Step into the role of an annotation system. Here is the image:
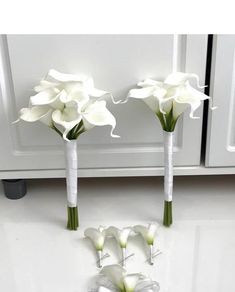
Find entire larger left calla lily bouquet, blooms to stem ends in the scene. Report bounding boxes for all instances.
[17,69,119,230]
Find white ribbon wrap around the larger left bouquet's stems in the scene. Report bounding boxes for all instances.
[65,140,77,207]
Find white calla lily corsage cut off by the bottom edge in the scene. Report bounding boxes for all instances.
[98,265,159,292]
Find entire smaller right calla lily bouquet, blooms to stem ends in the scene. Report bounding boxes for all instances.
[128,72,212,226]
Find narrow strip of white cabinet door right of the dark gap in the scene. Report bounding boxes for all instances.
[206,35,235,167]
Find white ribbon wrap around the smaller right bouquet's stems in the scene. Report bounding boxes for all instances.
[163,131,174,202]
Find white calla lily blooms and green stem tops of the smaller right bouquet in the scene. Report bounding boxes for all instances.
[128,72,210,132]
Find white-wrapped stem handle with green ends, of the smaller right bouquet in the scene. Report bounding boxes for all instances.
[163,131,173,227]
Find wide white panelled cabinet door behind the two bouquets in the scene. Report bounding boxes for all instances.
[0,35,207,176]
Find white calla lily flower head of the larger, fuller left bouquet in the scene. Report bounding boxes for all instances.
[18,69,119,140]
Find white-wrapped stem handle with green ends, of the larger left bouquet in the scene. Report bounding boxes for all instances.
[65,140,79,230]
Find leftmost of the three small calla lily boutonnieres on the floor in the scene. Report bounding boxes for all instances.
[84,226,105,268]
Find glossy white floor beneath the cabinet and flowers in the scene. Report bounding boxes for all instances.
[0,176,235,292]
